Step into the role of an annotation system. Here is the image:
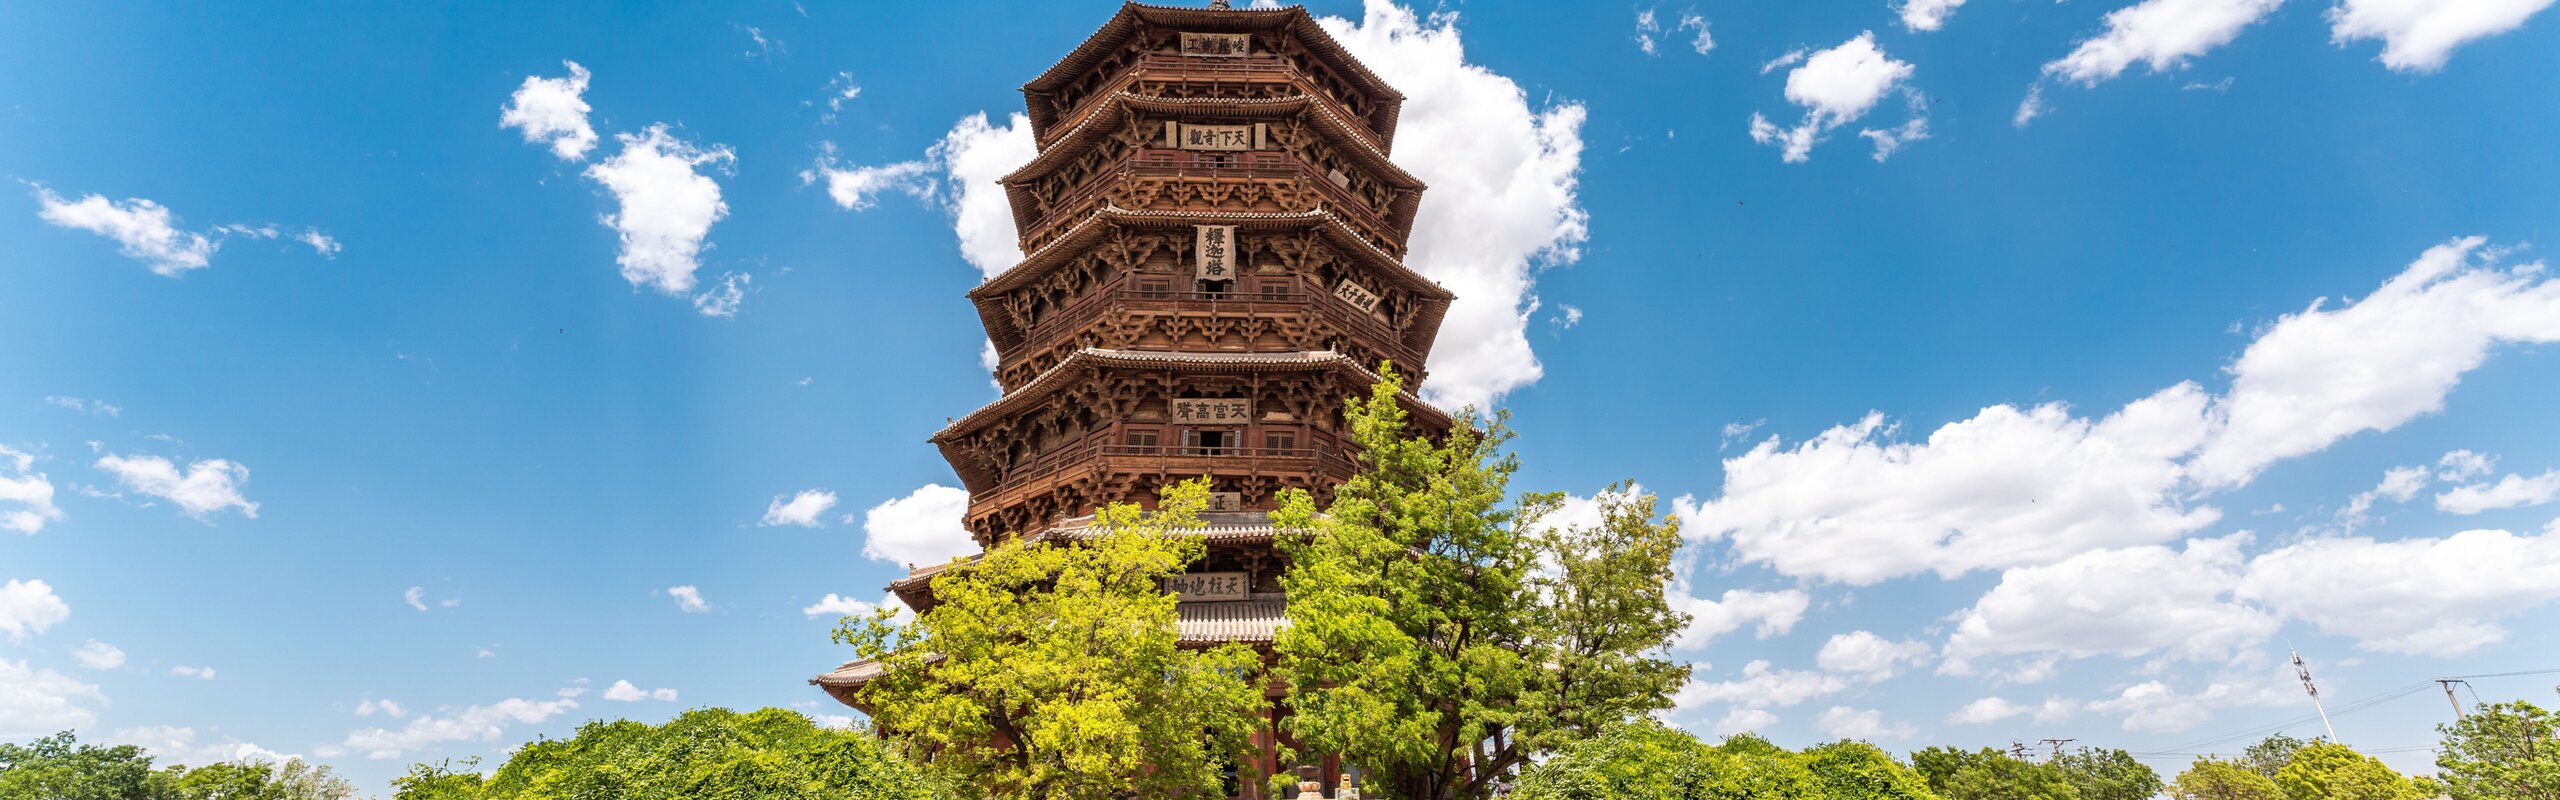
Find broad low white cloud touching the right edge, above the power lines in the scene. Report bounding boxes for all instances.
[2237,531,2560,654]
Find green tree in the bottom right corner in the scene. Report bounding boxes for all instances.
[2435,700,2560,800]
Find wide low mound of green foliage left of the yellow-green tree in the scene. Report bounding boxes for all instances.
[392,708,950,800]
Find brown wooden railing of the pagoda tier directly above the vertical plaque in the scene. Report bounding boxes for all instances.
[1021,149,1403,254]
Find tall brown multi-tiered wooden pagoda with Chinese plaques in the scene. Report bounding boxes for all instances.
[812,3,1452,797]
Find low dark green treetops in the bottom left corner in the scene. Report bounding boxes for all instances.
[0,731,356,800]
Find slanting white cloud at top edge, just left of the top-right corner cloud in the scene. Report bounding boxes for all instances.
[2045,0,2284,87]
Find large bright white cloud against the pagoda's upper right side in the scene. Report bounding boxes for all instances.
[1321,0,1590,405]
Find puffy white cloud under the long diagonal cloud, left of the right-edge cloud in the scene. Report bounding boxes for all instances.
[1946,533,2278,674]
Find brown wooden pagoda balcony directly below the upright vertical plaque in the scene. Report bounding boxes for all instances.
[996,274,1423,376]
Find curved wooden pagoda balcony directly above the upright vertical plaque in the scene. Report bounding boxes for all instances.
[1021,149,1413,259]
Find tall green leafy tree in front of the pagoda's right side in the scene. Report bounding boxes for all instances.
[1272,372,1687,800]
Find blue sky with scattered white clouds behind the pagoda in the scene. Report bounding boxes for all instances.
[0,0,2560,787]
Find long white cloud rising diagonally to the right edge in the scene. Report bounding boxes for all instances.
[1674,238,2560,585]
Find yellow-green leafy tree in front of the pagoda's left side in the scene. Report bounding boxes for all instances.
[837,479,1270,800]
